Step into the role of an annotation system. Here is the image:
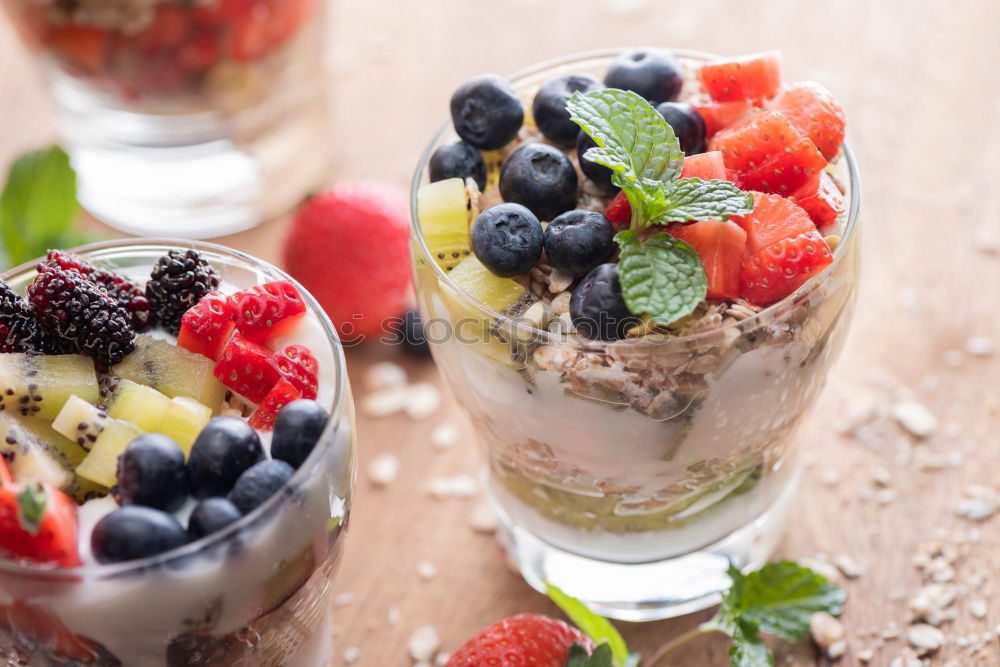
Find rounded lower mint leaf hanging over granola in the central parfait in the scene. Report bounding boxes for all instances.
[615,230,708,325]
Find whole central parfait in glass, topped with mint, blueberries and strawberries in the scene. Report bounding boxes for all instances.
[412,49,858,620]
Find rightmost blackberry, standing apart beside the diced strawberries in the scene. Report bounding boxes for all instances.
[146,250,219,336]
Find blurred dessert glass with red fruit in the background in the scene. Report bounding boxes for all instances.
[0,0,329,238]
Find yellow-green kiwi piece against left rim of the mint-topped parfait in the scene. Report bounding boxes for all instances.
[417,178,478,271]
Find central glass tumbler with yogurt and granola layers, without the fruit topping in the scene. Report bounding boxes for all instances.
[411,50,859,621]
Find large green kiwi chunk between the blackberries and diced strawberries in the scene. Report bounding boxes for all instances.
[111,336,226,414]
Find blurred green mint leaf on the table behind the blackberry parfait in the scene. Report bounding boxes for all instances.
[0,146,78,272]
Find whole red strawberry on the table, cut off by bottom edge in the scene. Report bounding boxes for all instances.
[446,614,594,667]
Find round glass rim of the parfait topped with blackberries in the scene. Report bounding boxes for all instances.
[0,237,349,581]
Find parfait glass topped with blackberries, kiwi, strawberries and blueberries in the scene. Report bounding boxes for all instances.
[0,241,354,666]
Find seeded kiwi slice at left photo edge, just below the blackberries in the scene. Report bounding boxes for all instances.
[0,353,98,419]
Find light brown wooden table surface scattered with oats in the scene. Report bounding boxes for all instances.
[0,0,1000,666]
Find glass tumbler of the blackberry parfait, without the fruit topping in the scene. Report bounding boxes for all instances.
[0,240,355,667]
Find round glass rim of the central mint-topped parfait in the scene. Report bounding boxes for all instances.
[410,47,861,349]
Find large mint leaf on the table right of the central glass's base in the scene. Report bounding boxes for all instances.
[720,561,847,642]
